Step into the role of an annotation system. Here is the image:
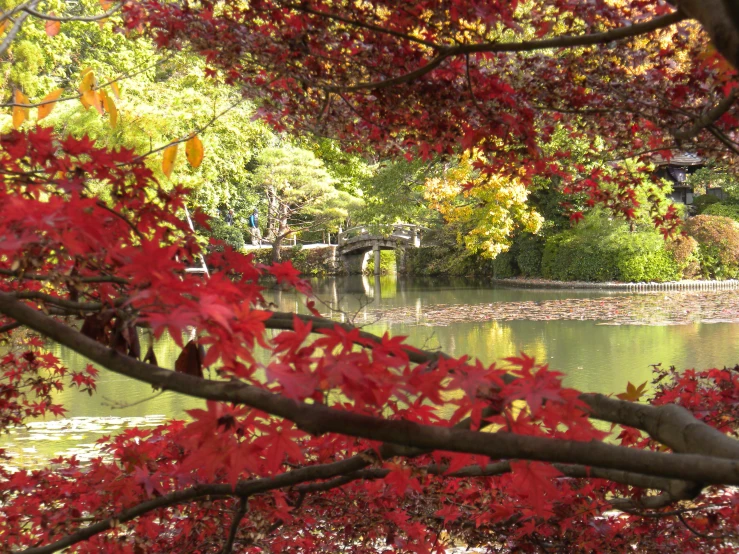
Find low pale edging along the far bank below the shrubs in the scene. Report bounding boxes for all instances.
[490,277,739,292]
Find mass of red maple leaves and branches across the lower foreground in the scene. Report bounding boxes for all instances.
[0,129,739,553]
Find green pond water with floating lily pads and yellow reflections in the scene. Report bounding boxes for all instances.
[0,276,739,467]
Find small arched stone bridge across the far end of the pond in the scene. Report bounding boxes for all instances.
[337,223,423,275]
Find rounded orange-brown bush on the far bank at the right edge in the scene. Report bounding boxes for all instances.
[684,215,739,279]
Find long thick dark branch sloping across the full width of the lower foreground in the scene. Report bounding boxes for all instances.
[0,293,739,485]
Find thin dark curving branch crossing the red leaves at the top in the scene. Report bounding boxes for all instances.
[322,11,687,93]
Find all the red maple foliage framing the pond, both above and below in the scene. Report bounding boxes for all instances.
[0,0,739,554]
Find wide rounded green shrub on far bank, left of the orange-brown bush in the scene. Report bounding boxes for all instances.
[542,213,680,282]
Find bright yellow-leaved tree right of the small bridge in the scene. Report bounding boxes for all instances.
[424,150,544,258]
